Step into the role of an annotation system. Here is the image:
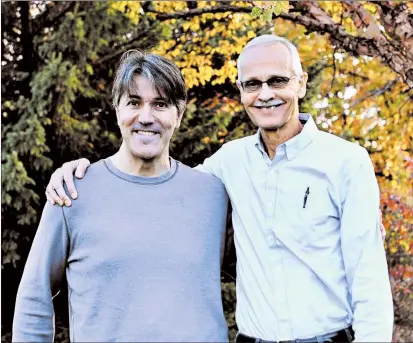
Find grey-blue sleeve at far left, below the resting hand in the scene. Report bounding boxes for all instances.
[12,202,69,342]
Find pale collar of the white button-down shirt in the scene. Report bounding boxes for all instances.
[254,113,318,160]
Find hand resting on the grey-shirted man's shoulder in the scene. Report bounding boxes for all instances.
[46,158,90,206]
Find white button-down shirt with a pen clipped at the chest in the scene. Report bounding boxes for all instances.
[197,114,393,342]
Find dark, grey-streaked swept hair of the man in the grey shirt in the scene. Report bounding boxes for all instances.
[112,50,187,115]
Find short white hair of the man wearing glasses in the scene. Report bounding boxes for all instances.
[237,35,303,80]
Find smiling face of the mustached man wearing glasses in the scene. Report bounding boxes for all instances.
[237,43,307,130]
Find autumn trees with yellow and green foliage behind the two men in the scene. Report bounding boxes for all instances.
[1,1,413,342]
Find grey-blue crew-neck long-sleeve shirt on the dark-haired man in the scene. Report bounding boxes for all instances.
[13,159,228,342]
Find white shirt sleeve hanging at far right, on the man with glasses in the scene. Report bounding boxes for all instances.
[341,149,393,342]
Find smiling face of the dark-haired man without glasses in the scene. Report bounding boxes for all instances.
[116,75,182,160]
